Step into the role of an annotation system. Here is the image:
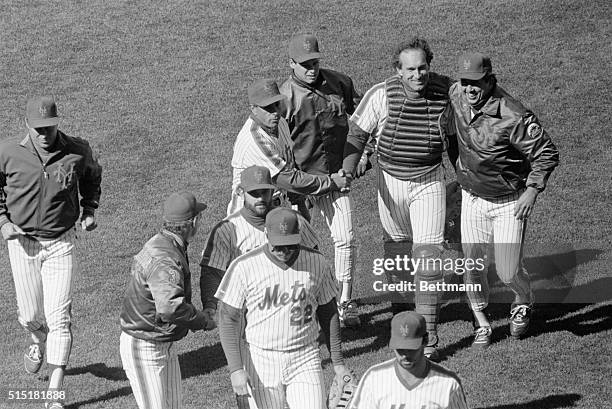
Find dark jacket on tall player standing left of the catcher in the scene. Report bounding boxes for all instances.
[280,69,359,175]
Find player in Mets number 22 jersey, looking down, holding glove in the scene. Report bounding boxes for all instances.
[215,207,348,409]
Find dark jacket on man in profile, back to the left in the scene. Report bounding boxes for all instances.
[120,230,206,342]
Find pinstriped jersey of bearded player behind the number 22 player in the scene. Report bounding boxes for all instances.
[200,210,319,271]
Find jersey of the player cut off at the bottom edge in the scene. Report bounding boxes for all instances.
[350,358,468,409]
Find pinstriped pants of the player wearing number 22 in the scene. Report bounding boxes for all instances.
[243,343,327,409]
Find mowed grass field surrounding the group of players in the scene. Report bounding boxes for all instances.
[0,0,612,409]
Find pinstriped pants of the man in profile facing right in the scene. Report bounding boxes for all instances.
[119,332,182,409]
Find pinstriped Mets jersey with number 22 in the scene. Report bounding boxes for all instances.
[215,245,337,351]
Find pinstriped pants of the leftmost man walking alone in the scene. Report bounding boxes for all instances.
[7,229,77,366]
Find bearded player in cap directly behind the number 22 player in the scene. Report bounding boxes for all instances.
[200,166,319,317]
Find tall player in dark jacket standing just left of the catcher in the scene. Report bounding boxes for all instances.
[280,34,361,327]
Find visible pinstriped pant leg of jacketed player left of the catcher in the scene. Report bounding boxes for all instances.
[310,191,357,282]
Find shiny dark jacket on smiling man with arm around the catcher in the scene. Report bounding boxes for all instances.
[450,83,559,198]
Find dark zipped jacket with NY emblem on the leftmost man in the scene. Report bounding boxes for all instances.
[0,131,102,238]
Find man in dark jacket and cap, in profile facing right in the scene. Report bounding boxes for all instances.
[120,192,215,409]
